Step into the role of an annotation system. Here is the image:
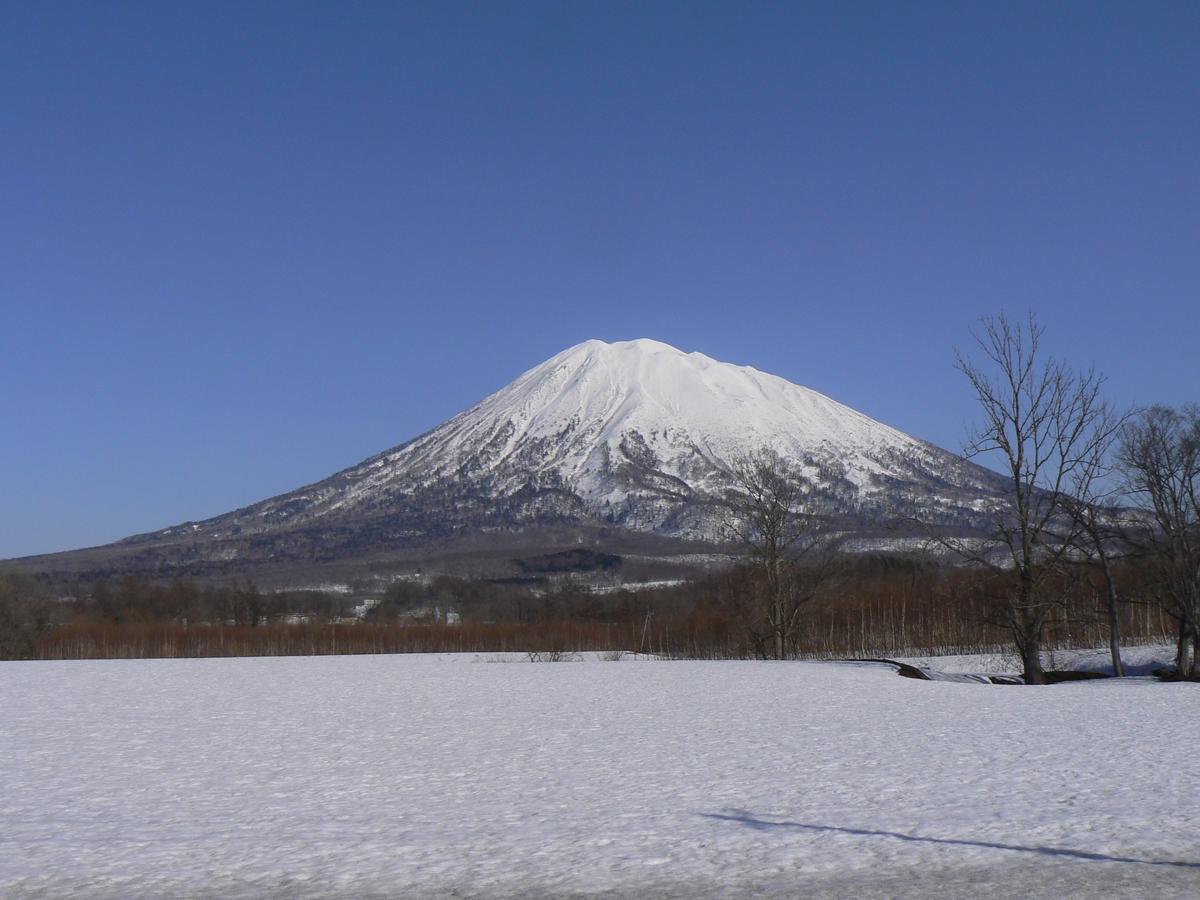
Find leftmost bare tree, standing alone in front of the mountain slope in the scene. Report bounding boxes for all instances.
[725,450,838,659]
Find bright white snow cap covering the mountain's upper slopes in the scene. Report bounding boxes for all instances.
[369,338,928,500]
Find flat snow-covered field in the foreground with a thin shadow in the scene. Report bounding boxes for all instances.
[0,655,1200,898]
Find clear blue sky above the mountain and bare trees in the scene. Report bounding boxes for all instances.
[0,0,1200,557]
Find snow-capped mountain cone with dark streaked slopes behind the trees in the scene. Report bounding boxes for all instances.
[18,338,997,585]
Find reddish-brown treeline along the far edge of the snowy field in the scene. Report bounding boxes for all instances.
[0,554,1174,659]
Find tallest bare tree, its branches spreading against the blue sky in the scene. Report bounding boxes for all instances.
[943,313,1111,684]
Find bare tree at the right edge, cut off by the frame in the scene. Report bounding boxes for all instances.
[1117,404,1200,677]
